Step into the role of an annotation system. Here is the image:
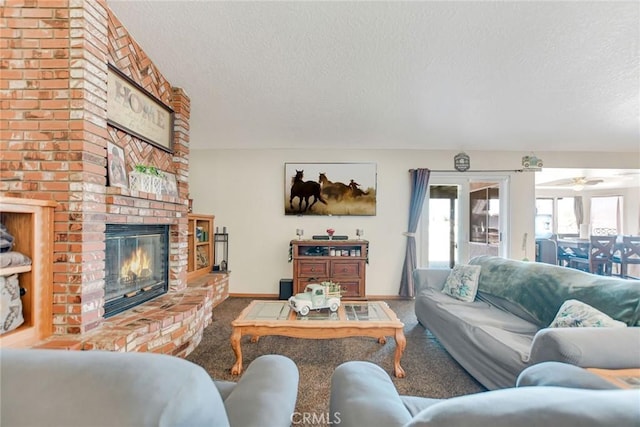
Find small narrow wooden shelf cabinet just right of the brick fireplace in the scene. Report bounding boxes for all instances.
[187,214,214,280]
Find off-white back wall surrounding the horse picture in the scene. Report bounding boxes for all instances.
[189,150,637,296]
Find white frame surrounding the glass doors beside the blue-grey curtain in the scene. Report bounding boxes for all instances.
[416,172,511,267]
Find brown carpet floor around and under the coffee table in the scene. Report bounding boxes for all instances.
[187,298,485,422]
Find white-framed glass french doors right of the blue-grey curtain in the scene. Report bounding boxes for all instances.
[416,172,509,268]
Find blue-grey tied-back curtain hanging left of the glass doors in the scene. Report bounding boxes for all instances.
[399,169,431,298]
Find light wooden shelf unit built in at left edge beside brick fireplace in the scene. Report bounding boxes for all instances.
[0,196,57,347]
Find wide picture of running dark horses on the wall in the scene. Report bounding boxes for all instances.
[284,163,377,216]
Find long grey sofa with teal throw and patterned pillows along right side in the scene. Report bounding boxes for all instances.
[413,256,640,390]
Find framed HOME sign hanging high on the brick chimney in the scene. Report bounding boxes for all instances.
[107,64,174,153]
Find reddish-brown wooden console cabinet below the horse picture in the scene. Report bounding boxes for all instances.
[291,240,369,299]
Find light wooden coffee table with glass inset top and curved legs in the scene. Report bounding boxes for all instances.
[231,300,407,378]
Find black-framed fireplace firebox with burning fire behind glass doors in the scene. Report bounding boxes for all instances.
[104,224,169,318]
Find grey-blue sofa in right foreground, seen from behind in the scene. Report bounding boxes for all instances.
[329,361,640,427]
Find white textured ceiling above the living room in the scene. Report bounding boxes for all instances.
[108,0,640,152]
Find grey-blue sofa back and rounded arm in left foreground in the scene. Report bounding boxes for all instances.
[0,349,298,427]
